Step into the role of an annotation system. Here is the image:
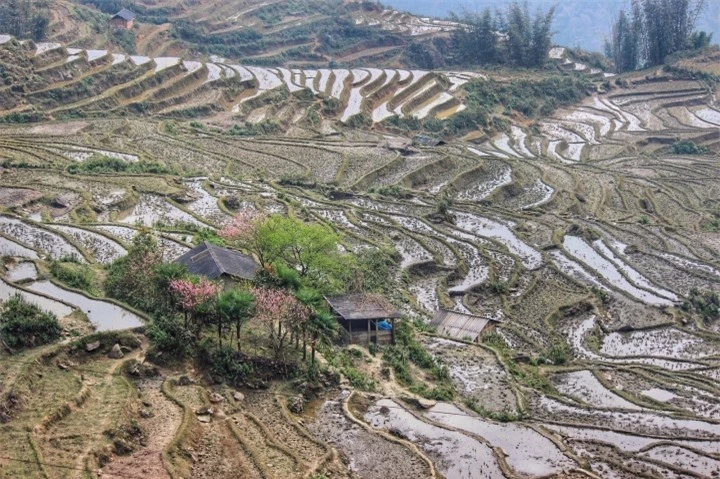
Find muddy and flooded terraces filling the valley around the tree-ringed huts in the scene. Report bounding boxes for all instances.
[0,69,720,479]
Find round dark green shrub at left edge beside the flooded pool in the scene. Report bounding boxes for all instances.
[0,294,62,348]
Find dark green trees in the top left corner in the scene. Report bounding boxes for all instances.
[0,0,50,41]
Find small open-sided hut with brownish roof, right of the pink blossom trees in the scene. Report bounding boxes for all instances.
[325,293,402,344]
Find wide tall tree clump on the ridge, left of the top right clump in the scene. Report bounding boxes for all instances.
[450,1,555,68]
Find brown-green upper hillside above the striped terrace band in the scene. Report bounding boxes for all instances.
[35,0,456,66]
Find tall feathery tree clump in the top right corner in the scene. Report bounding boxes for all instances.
[605,0,712,72]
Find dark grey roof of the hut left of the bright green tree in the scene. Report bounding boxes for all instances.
[175,242,260,279]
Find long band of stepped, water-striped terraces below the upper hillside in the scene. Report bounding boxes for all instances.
[0,36,496,125]
